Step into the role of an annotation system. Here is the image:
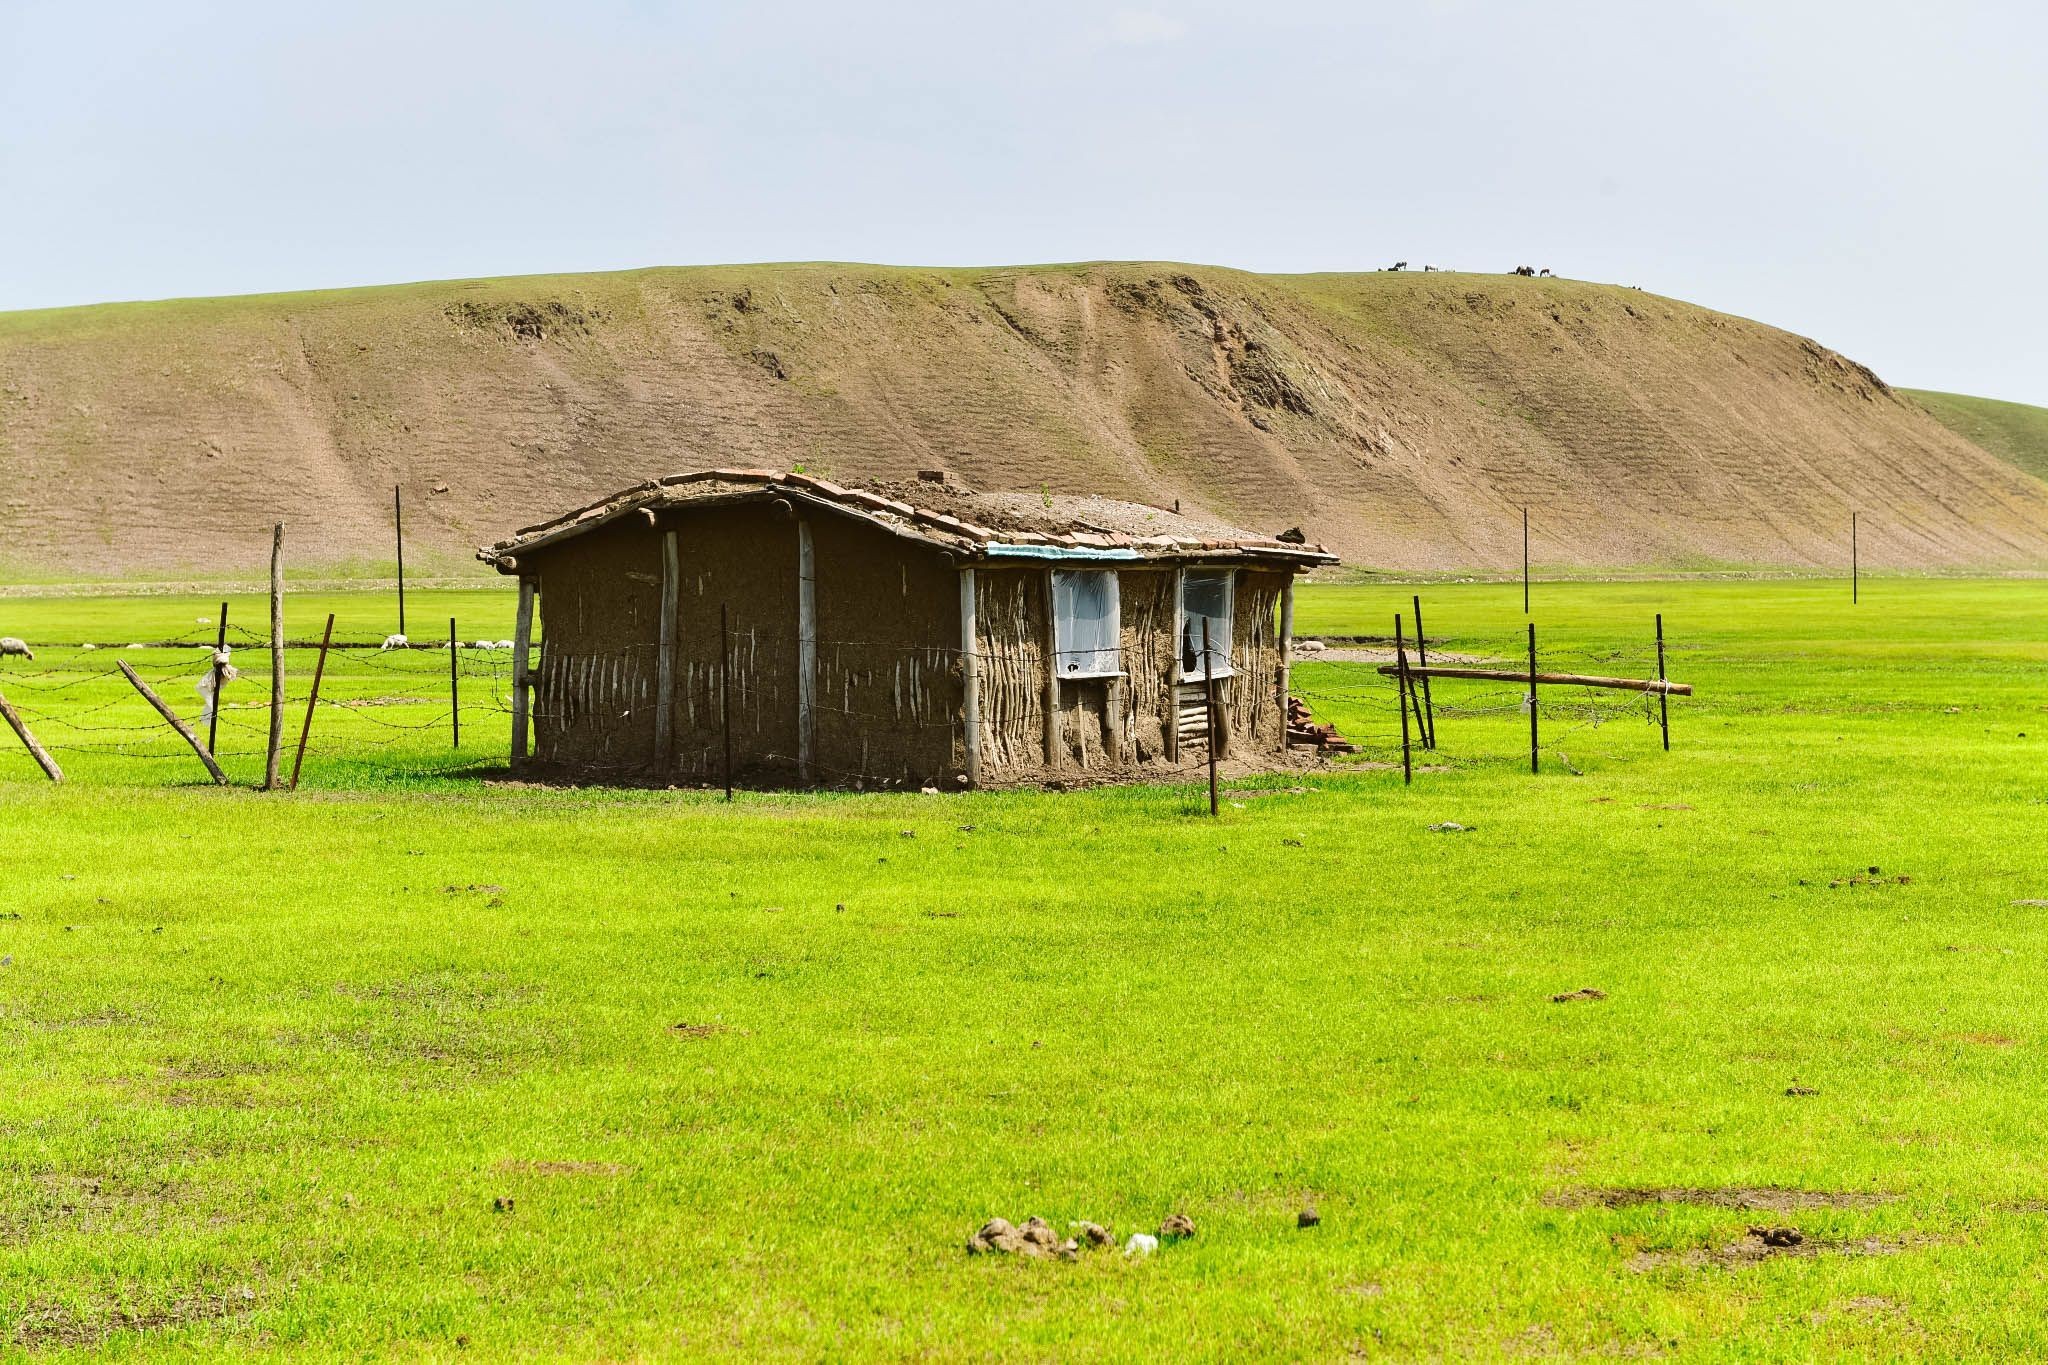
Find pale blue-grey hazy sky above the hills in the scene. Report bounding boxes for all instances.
[0,0,2048,405]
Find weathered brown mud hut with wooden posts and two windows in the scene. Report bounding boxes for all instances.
[477,469,1335,788]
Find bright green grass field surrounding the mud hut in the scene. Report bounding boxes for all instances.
[0,579,2048,1359]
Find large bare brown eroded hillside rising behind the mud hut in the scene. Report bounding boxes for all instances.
[0,264,2048,575]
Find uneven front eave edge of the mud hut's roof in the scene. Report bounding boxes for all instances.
[477,469,1337,573]
